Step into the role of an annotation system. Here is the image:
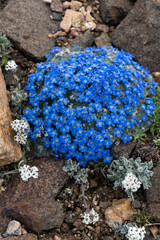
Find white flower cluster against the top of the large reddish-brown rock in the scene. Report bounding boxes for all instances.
[18,165,38,182]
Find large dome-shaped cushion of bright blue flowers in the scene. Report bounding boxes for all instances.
[24,47,156,166]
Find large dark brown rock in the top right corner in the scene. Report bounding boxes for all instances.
[111,0,160,72]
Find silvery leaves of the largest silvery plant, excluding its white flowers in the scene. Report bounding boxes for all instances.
[107,157,153,201]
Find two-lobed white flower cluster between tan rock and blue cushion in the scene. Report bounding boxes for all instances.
[11,119,29,144]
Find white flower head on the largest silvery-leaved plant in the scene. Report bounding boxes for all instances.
[122,173,141,192]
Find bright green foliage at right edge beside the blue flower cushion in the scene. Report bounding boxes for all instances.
[151,87,160,136]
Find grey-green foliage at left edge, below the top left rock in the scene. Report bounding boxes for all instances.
[0,32,11,67]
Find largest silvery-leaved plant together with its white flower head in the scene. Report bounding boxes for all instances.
[107,157,153,201]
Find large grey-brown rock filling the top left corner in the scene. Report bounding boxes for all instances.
[0,0,59,60]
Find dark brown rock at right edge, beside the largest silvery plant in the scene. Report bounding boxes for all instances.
[145,161,160,204]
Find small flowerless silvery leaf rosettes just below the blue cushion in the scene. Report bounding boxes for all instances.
[63,158,89,188]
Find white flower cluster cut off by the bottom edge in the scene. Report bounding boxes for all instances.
[126,227,146,240]
